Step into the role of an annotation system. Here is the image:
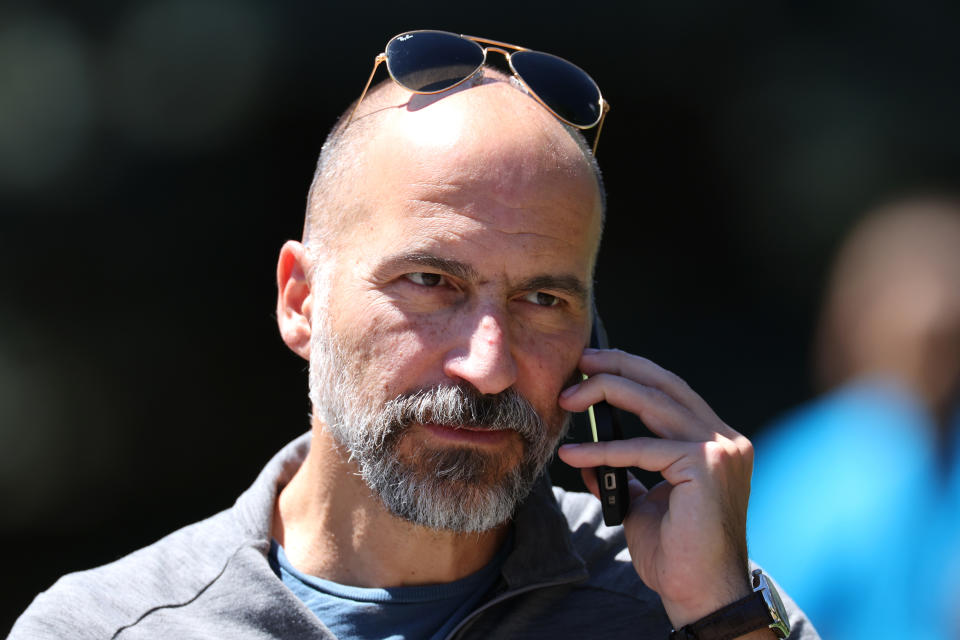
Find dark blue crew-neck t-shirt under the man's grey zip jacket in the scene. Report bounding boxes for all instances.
[269,532,513,640]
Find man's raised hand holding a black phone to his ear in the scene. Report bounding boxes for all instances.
[558,327,753,628]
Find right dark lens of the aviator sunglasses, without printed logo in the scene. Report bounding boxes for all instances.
[510,51,600,128]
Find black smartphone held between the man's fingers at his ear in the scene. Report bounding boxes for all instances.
[584,309,630,527]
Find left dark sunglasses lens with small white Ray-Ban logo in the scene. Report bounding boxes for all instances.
[386,31,483,93]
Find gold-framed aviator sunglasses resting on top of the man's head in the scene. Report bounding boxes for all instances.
[347,31,610,154]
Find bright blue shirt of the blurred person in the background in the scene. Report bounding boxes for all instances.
[747,380,960,640]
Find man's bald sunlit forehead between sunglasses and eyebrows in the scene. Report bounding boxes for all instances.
[342,82,601,260]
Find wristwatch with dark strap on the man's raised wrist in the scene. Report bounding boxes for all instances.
[670,569,790,640]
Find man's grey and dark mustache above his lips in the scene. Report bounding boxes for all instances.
[384,385,544,441]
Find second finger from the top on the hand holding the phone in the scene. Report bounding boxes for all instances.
[558,373,704,441]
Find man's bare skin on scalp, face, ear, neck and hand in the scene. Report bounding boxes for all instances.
[274,76,773,638]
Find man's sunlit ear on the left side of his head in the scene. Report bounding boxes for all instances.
[277,240,313,360]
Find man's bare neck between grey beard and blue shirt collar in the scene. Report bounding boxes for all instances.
[273,423,509,587]
